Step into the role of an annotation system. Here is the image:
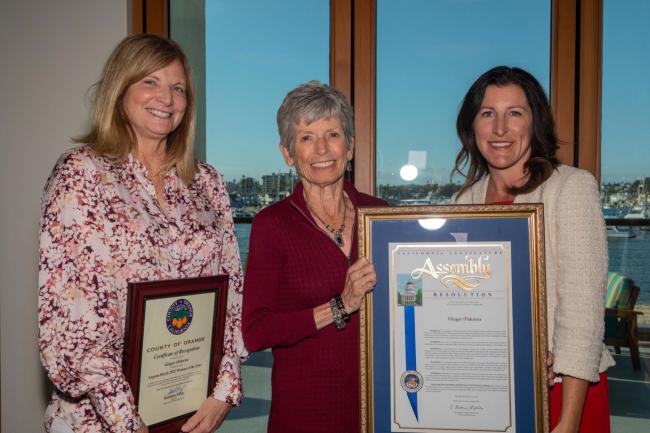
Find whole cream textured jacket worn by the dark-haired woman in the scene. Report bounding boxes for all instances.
[455,165,614,381]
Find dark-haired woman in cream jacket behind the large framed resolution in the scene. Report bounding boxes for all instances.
[454,66,614,433]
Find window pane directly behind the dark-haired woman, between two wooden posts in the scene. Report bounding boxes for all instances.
[376,0,551,204]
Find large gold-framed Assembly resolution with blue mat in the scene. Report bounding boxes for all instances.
[359,204,549,433]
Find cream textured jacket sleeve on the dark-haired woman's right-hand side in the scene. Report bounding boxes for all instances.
[551,170,607,381]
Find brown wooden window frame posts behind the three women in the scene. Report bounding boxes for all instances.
[132,0,603,194]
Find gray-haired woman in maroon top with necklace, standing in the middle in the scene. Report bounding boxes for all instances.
[242,81,386,433]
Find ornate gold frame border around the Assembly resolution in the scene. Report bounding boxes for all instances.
[358,203,550,433]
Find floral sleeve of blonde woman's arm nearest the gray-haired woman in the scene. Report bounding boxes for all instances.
[212,171,248,406]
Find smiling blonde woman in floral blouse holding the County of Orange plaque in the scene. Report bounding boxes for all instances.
[39,34,247,433]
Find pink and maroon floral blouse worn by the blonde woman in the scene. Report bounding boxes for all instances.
[38,146,247,433]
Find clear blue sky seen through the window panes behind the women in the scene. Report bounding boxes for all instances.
[201,0,650,184]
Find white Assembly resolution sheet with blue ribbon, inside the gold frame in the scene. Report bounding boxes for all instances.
[388,242,515,433]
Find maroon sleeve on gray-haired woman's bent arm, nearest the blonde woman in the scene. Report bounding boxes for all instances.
[243,213,317,352]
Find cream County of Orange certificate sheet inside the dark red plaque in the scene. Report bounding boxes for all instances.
[138,292,216,425]
